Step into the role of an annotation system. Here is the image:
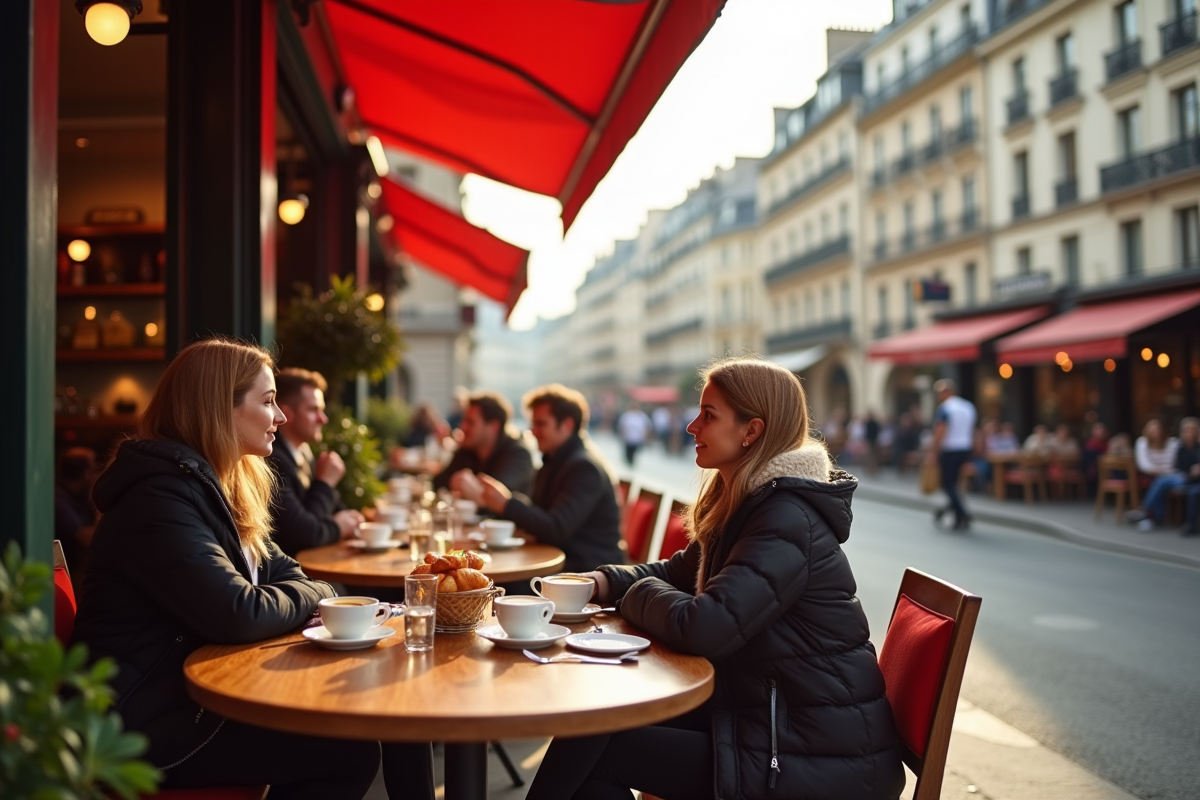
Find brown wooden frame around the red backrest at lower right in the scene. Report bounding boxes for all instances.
[892,567,983,800]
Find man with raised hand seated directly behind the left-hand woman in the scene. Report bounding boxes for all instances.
[266,367,362,557]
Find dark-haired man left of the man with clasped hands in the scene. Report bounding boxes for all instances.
[433,392,533,495]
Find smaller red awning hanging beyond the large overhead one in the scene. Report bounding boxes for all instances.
[383,180,529,313]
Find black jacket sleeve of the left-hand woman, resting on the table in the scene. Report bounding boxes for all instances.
[122,479,334,644]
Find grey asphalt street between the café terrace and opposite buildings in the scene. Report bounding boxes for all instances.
[599,439,1200,800]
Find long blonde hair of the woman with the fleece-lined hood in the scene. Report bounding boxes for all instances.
[686,356,809,545]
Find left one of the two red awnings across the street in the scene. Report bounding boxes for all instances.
[866,306,1050,363]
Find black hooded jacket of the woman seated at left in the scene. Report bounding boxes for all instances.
[73,440,334,769]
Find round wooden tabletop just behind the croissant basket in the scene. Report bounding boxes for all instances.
[296,542,566,587]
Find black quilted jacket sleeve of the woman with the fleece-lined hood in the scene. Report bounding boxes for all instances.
[609,504,812,660]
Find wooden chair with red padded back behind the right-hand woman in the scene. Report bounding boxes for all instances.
[880,569,983,800]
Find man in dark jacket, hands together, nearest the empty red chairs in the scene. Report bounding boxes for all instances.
[463,384,625,572]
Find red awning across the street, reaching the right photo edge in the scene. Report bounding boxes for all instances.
[996,289,1200,363]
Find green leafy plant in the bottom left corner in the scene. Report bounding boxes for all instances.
[0,542,161,800]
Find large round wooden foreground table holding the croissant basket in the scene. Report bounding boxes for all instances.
[184,615,713,800]
